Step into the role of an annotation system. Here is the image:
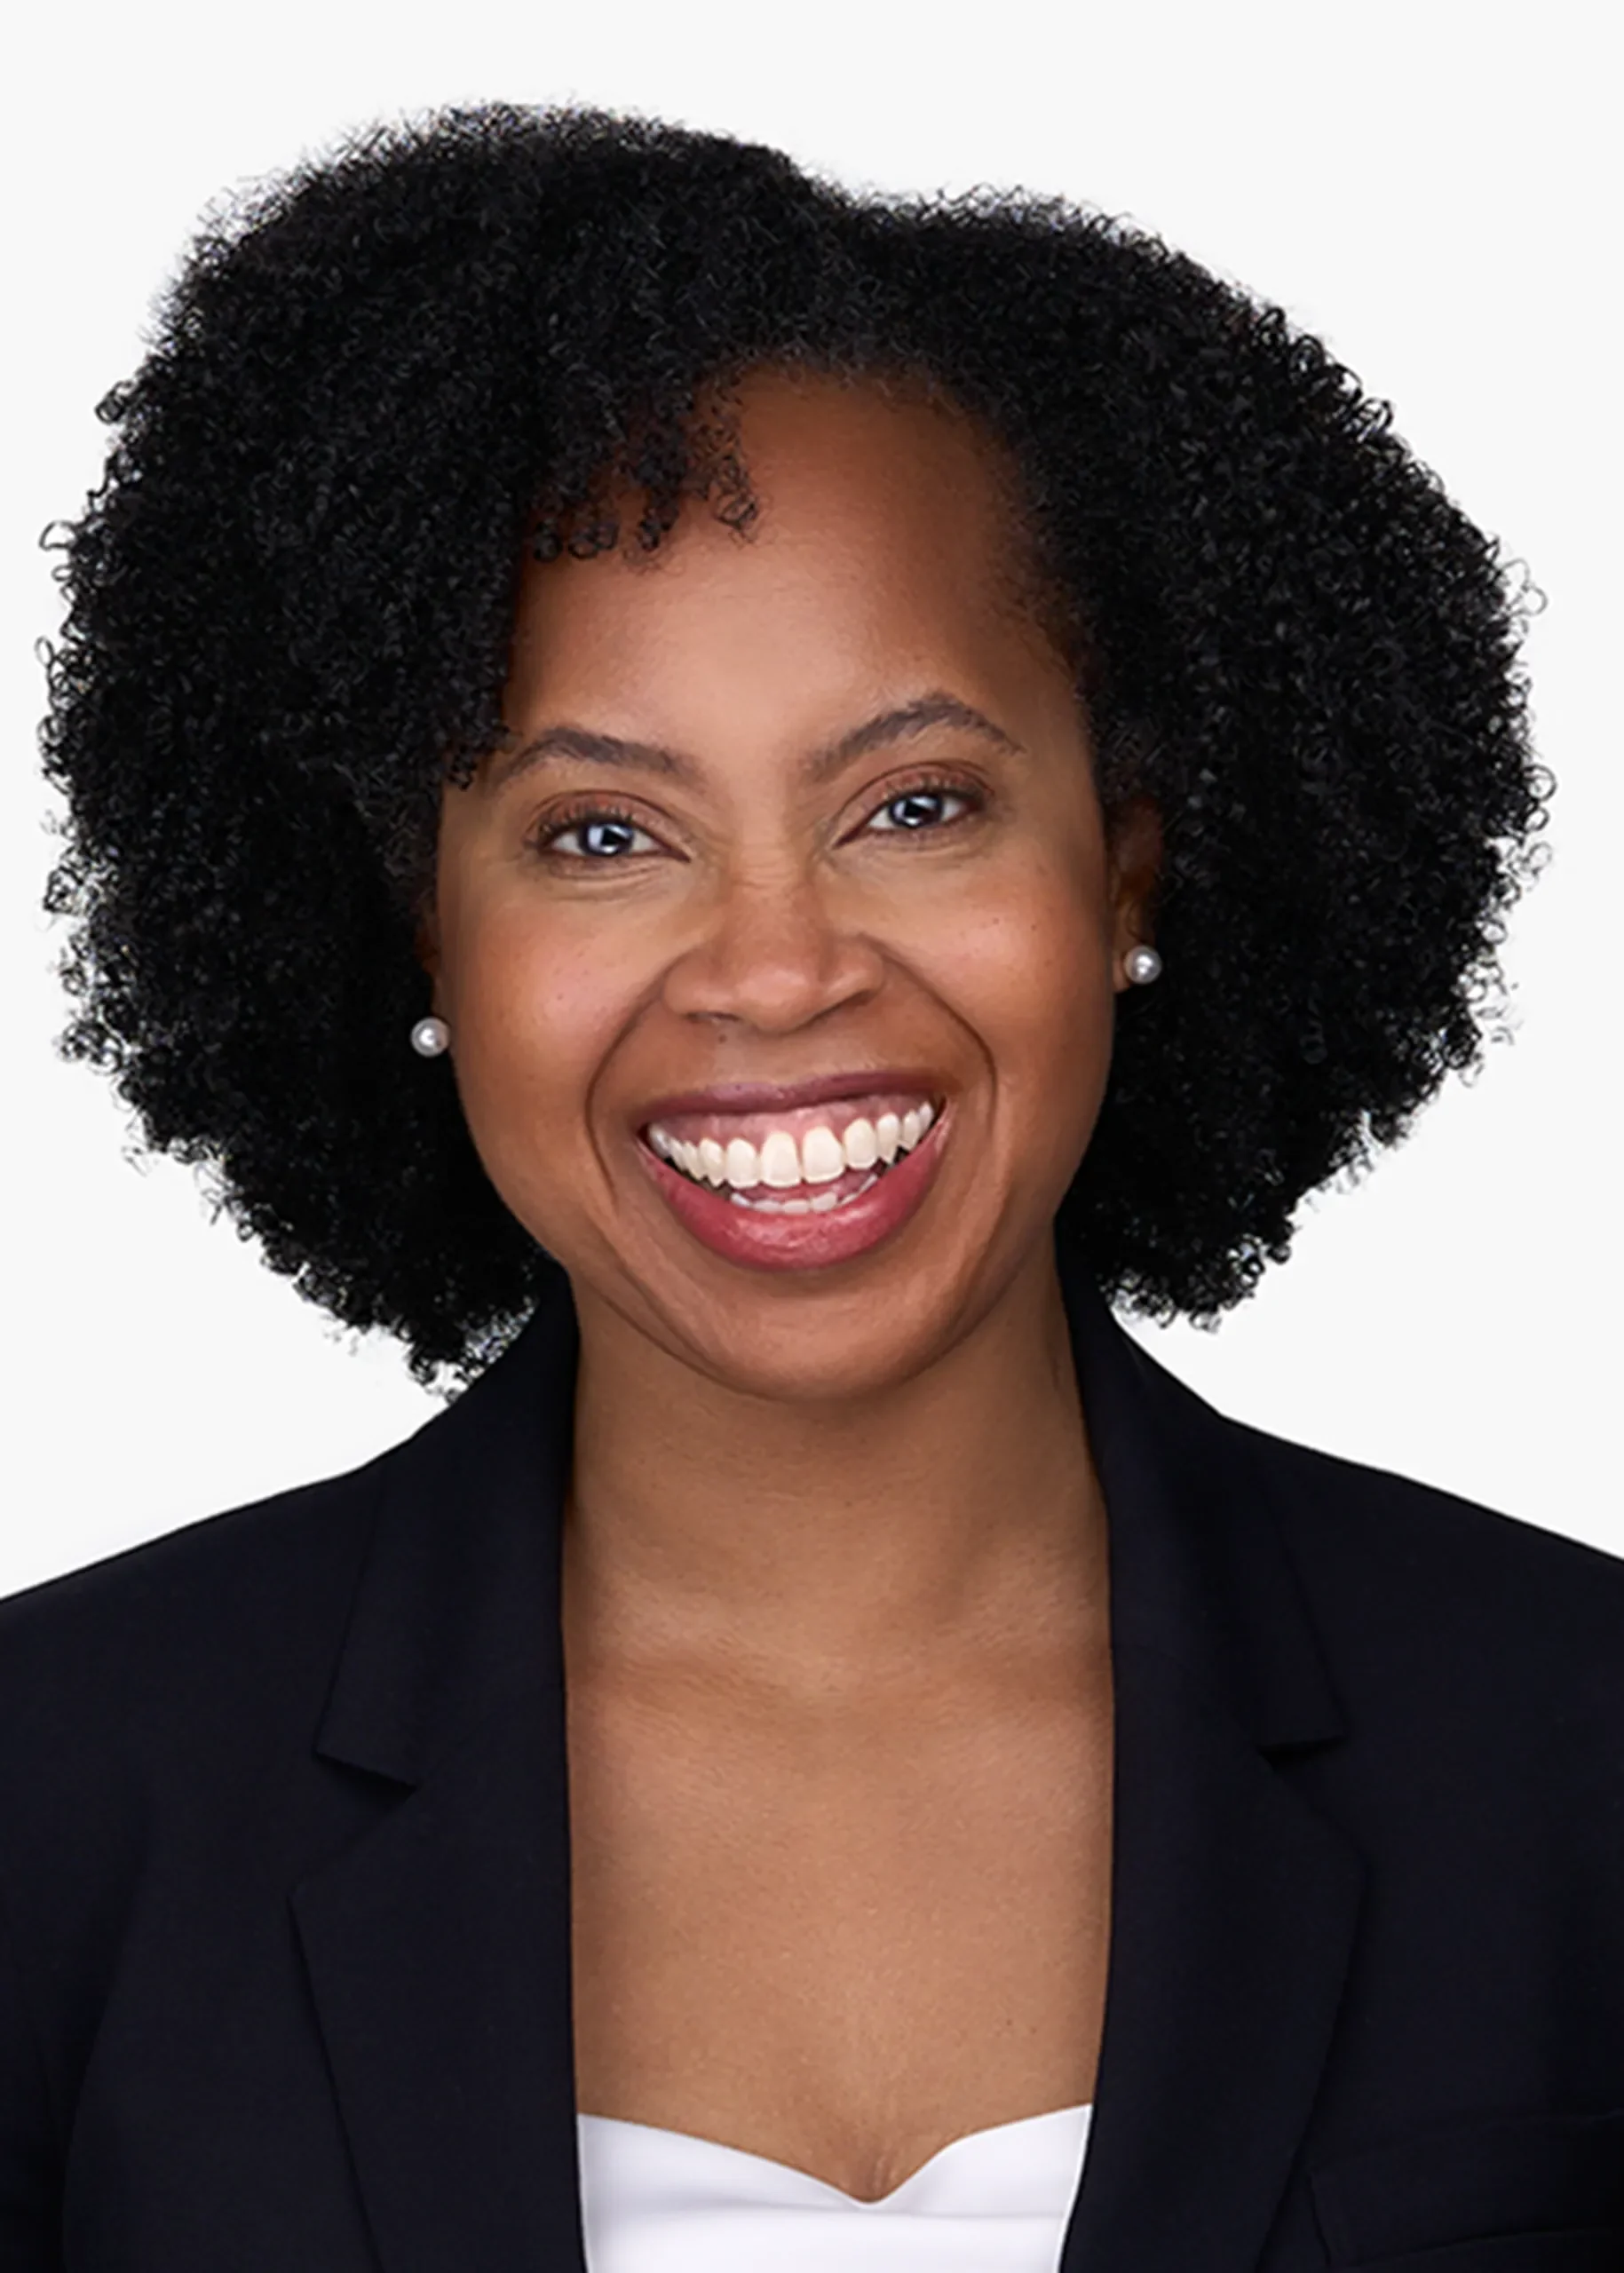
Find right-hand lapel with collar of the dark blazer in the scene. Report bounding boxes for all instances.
[1060,1259,1362,2273]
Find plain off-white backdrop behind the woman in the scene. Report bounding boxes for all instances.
[0,0,1624,1591]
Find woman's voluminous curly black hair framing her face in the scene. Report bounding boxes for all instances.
[44,107,1549,1380]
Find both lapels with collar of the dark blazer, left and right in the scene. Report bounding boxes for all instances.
[293,1247,1360,2273]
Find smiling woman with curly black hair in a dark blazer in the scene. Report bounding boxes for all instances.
[0,111,1624,2273]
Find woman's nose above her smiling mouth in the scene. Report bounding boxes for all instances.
[664,873,884,1034]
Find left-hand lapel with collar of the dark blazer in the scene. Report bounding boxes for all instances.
[293,1282,584,2273]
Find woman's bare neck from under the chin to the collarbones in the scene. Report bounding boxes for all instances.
[564,1243,1105,1693]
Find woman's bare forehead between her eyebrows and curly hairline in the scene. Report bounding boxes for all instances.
[510,373,1033,707]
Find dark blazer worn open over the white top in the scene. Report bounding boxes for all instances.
[0,1236,1624,2273]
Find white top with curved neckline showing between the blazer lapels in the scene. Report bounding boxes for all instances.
[575,2107,1094,2273]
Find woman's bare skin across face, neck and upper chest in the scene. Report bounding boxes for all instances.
[423,373,1158,2200]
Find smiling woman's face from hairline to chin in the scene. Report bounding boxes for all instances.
[423,375,1155,1400]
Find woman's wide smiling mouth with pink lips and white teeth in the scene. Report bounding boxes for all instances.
[637,1091,951,1271]
